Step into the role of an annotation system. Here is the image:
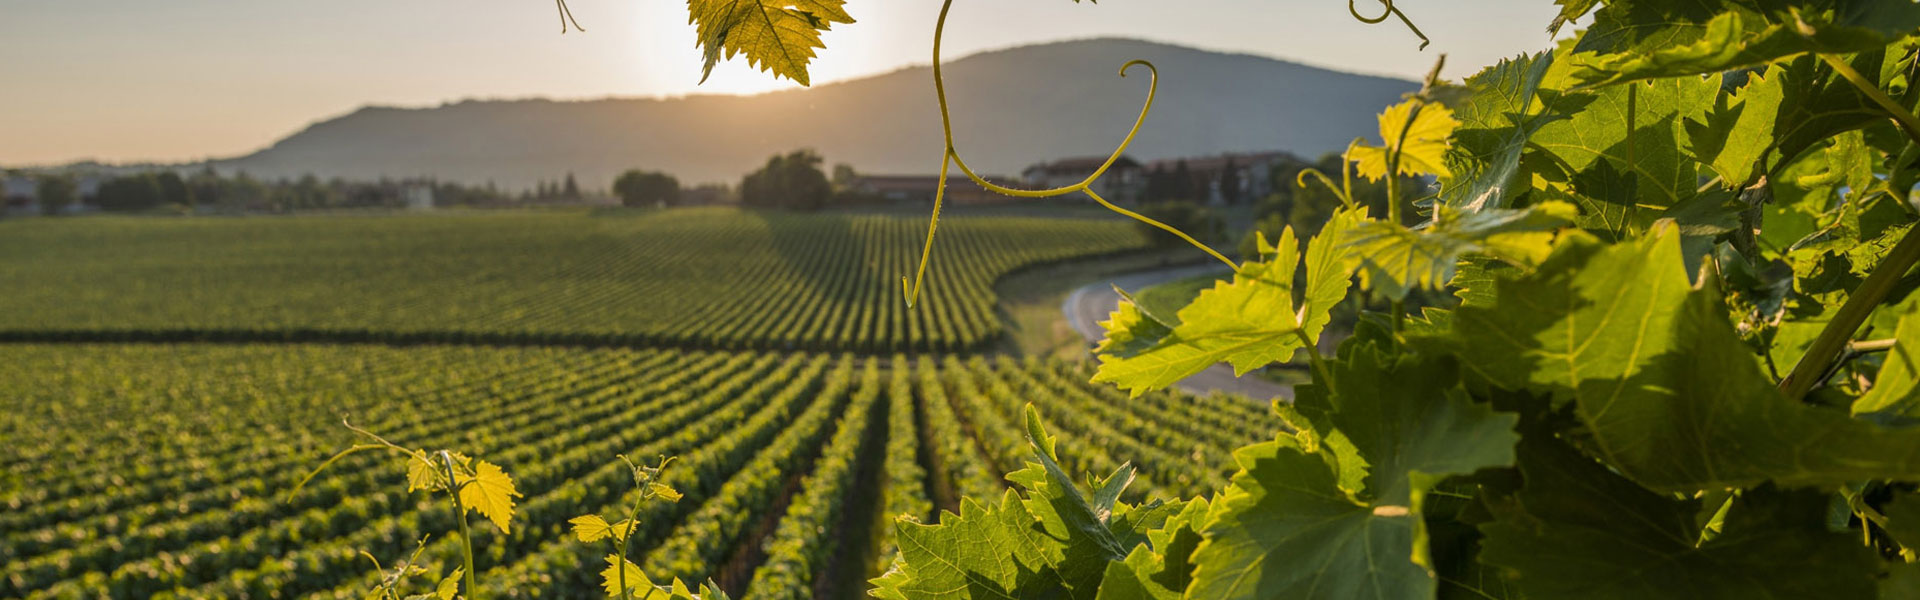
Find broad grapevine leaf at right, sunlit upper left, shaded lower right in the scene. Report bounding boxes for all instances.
[1428,223,1920,492]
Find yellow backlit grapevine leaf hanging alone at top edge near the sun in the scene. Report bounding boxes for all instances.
[687,0,852,85]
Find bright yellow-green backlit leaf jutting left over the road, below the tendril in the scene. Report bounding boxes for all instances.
[1092,210,1367,396]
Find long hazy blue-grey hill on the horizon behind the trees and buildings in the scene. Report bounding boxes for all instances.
[215,38,1415,188]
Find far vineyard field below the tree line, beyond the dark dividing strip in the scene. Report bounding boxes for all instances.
[0,210,1144,352]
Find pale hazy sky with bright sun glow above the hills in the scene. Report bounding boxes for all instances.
[0,0,1555,165]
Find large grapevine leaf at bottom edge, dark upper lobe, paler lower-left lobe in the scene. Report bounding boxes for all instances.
[1188,344,1519,598]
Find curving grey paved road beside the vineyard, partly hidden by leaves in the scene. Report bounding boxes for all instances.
[1060,263,1294,404]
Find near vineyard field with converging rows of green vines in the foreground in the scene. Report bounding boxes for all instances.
[11,344,1277,598]
